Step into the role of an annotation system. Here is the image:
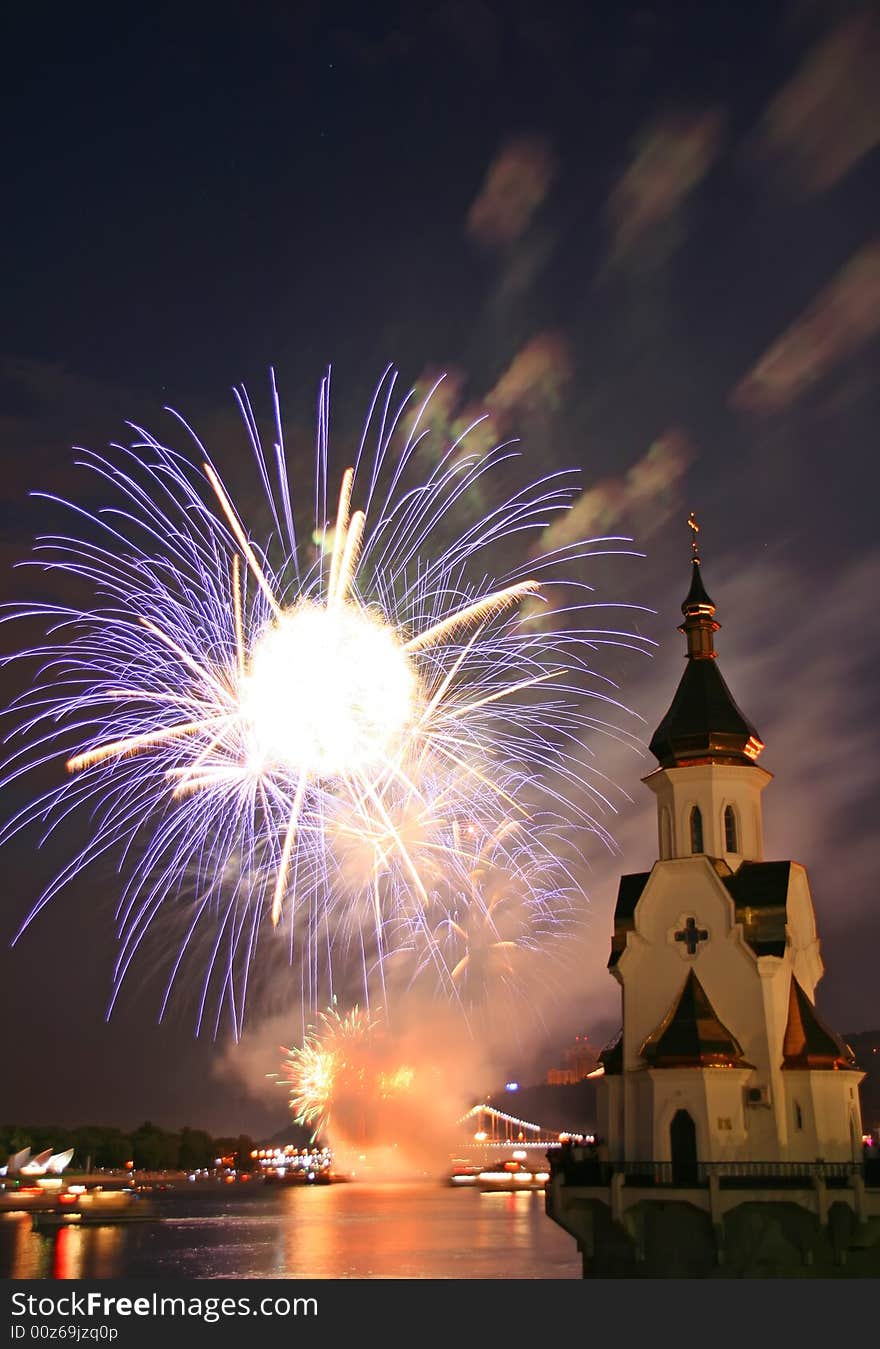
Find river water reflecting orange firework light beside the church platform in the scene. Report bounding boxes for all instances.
[0,1182,580,1279]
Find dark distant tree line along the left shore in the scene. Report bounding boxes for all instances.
[0,1120,256,1171]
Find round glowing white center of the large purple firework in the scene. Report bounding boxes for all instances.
[242,600,418,778]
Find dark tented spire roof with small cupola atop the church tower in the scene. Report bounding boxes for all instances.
[651,558,764,768]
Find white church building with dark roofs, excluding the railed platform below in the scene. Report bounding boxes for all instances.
[599,517,864,1179]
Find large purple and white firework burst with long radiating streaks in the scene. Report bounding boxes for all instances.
[0,367,652,1036]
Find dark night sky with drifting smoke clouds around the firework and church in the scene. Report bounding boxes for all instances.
[0,0,880,1133]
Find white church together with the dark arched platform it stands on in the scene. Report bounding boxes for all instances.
[547,517,880,1276]
